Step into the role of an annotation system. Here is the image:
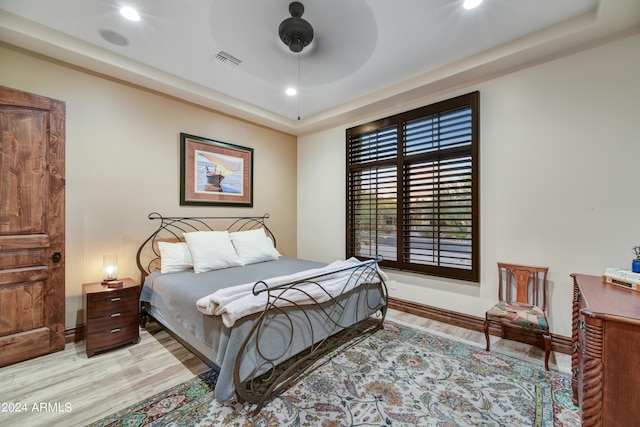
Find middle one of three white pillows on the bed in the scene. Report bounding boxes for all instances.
[184,231,243,273]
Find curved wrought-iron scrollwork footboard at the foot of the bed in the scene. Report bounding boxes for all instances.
[233,260,387,414]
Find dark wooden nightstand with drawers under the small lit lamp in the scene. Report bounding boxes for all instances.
[82,279,140,357]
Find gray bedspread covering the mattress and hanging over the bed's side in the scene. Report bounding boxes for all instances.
[140,257,383,402]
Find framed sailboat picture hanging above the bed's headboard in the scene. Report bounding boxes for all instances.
[180,133,253,207]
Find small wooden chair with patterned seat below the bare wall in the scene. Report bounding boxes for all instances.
[484,262,551,370]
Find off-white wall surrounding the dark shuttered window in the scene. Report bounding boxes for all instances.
[298,34,640,336]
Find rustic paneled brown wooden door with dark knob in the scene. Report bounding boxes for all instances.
[0,86,66,366]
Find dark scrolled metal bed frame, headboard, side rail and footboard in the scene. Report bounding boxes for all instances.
[136,212,388,414]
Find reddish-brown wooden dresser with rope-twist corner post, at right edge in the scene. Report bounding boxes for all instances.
[571,274,640,427]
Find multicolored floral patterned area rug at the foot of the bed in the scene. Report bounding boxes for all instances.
[87,322,580,427]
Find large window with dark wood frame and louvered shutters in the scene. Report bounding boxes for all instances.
[346,92,480,282]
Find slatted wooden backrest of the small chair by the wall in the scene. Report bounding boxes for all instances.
[498,262,549,311]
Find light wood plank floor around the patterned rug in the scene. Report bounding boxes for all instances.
[0,310,571,427]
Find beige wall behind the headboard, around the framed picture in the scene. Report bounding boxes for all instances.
[0,44,296,327]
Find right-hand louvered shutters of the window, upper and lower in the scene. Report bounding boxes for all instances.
[402,108,472,270]
